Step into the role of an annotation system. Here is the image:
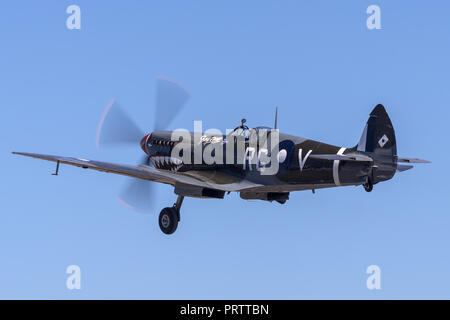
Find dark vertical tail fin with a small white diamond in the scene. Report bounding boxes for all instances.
[356,104,397,183]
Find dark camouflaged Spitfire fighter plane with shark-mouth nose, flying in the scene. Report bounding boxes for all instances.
[13,78,430,234]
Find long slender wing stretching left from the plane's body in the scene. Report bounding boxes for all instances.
[13,152,259,191]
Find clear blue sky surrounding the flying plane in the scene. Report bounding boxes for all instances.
[0,0,450,299]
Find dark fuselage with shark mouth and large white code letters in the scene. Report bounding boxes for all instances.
[141,131,370,192]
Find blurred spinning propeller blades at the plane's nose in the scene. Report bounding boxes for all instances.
[96,76,190,212]
